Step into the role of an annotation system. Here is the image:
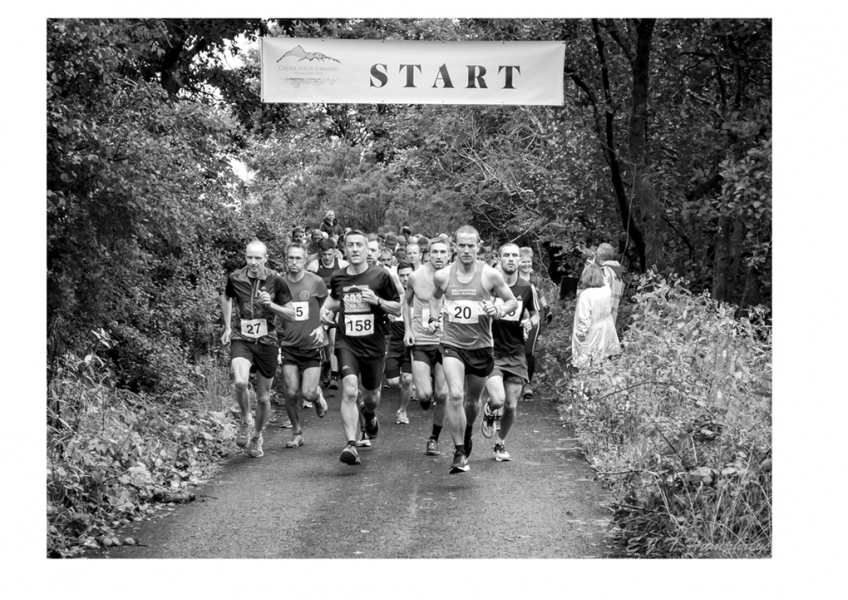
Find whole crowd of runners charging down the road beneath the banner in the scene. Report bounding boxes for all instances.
[221,223,564,474]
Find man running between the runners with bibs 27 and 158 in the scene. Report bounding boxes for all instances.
[280,240,329,448]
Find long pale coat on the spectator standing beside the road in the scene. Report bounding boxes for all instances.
[571,286,621,367]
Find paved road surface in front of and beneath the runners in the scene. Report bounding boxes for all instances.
[105,390,609,558]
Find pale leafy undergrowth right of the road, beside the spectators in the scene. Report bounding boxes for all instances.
[542,272,772,557]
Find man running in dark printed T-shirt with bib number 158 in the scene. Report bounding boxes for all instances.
[321,231,401,465]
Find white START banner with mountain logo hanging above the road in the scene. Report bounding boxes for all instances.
[261,37,565,106]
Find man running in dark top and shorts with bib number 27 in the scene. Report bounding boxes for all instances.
[221,240,295,458]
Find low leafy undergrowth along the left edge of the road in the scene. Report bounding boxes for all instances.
[47,337,236,558]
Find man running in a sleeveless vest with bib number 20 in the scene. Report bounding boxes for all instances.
[429,225,518,473]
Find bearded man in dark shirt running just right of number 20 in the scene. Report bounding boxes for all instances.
[481,243,539,462]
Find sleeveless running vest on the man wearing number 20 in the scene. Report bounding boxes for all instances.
[442,260,492,350]
